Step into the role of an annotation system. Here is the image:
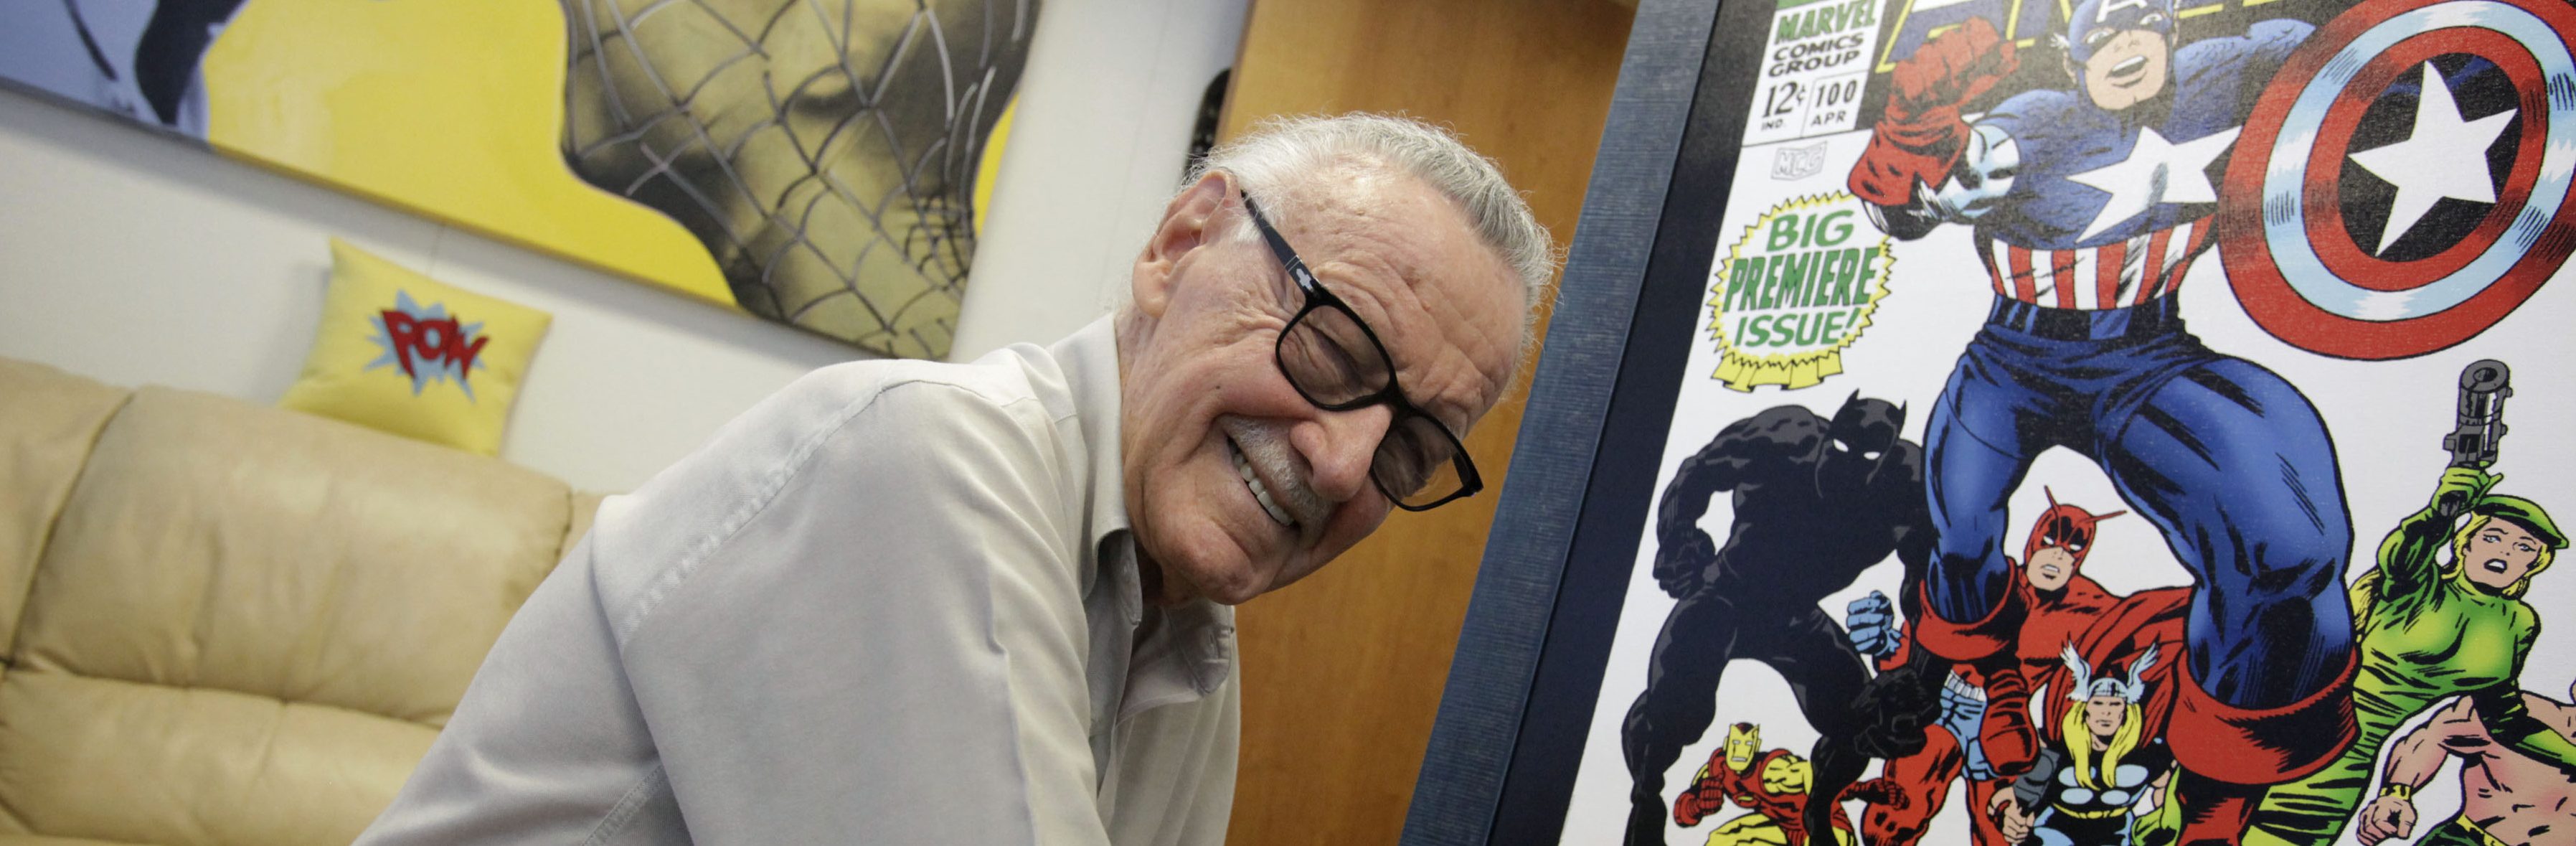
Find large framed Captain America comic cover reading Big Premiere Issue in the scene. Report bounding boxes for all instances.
[1407,0,2576,846]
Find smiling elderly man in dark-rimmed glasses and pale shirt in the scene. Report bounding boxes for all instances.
[361,116,1553,843]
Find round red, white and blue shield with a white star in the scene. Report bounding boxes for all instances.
[2215,0,2576,359]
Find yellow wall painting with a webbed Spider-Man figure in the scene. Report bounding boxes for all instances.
[0,0,1041,359]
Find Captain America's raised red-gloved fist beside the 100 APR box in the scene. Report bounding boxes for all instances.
[1849,18,2019,207]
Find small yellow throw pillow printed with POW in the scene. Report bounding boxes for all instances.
[278,238,554,454]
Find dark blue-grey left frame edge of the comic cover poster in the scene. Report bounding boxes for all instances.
[1402,0,1775,846]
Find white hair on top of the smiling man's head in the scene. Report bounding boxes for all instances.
[1182,113,1556,348]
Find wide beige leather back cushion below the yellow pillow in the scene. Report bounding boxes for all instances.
[18,387,572,725]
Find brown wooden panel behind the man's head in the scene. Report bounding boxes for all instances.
[1221,0,1633,846]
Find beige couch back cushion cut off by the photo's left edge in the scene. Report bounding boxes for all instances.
[0,359,126,660]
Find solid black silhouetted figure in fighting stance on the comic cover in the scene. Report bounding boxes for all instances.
[1620,392,1932,846]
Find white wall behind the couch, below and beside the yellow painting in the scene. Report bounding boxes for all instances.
[0,0,1242,490]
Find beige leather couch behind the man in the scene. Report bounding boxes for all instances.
[0,359,598,846]
